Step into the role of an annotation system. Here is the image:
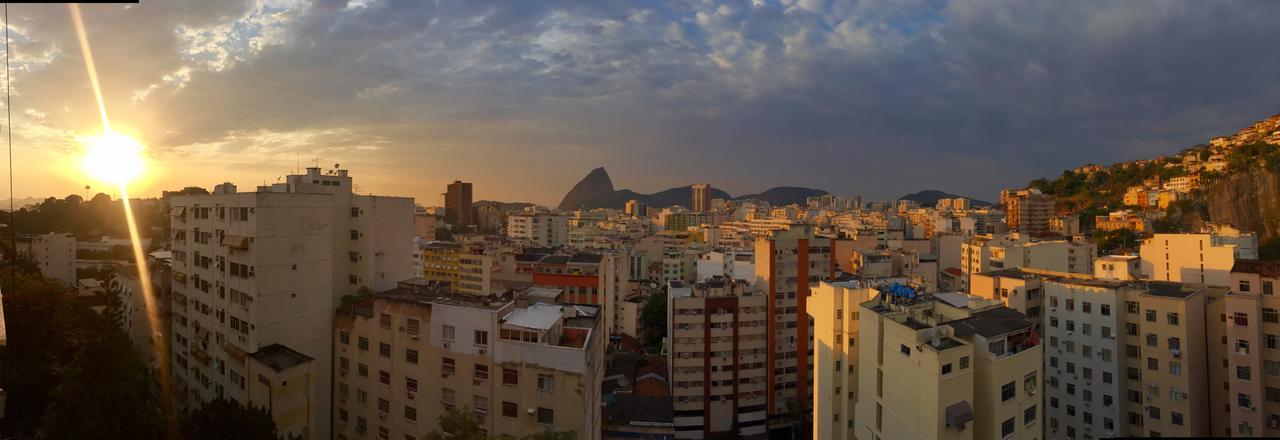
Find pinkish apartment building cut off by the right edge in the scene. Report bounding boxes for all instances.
[1208,260,1280,437]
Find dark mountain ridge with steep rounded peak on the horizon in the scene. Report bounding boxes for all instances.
[558,168,828,210]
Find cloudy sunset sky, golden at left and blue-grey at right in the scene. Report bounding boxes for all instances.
[0,0,1280,206]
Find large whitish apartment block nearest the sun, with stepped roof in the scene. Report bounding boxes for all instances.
[169,168,413,439]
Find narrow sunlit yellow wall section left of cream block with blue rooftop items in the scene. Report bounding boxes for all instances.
[806,280,879,440]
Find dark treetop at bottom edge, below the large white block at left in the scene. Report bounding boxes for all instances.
[183,399,279,440]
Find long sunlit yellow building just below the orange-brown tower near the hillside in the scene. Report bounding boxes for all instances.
[960,233,1098,287]
